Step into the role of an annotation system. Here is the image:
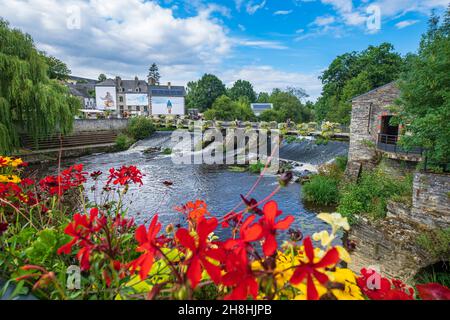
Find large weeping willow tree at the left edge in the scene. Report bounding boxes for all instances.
[0,19,80,154]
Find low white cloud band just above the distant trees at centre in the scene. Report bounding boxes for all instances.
[221,65,322,100]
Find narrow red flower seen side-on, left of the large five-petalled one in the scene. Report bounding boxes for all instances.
[131,215,161,280]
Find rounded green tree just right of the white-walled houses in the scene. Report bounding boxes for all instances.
[186,74,226,112]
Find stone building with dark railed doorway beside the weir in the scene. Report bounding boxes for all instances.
[347,82,422,180]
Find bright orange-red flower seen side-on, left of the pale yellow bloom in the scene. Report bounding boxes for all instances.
[261,200,294,256]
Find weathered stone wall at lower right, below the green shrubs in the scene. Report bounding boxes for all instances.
[348,172,450,281]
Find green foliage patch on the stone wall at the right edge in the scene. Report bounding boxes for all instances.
[417,228,450,262]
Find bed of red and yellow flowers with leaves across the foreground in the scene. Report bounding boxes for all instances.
[0,157,450,300]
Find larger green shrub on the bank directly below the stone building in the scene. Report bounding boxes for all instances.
[337,169,412,223]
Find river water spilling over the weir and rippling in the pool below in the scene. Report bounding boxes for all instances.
[37,132,347,240]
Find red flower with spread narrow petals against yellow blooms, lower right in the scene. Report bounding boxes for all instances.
[290,237,339,300]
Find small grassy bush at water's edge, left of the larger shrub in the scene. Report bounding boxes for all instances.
[302,175,339,205]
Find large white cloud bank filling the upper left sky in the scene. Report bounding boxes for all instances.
[0,0,234,84]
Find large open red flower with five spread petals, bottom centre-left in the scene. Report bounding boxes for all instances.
[175,218,224,288]
